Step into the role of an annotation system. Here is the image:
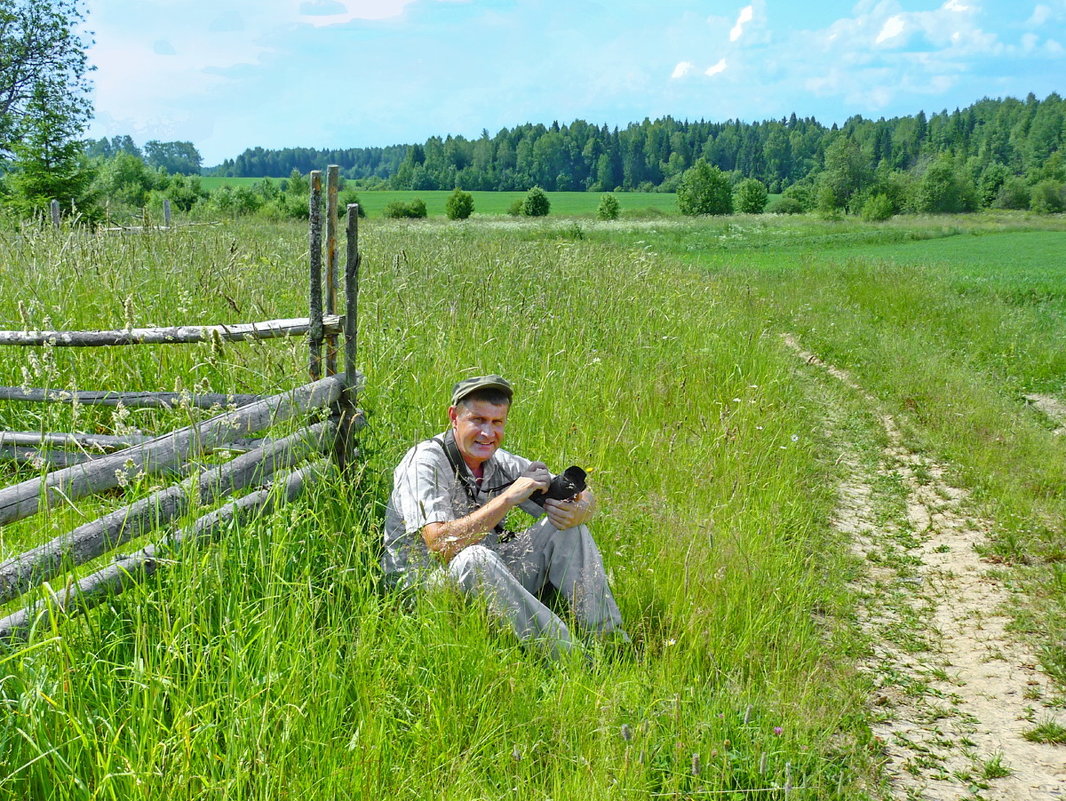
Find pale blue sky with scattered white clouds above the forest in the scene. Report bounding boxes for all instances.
[86,0,1066,165]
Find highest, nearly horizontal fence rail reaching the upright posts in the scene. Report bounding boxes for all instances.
[0,315,342,348]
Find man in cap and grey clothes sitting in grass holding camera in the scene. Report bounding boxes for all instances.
[383,375,628,655]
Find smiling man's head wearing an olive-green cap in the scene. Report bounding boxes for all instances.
[448,375,514,474]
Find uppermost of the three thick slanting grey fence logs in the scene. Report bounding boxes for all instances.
[0,377,344,525]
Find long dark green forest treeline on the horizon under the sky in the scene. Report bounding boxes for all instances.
[209,93,1066,193]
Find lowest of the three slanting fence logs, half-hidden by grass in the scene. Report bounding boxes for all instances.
[0,461,329,640]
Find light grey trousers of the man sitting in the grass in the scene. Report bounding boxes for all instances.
[448,517,626,655]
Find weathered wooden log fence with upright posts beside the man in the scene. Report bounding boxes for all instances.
[0,165,365,640]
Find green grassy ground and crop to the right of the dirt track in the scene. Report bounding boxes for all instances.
[605,217,1066,682]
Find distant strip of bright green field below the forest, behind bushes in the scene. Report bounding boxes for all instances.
[200,177,678,217]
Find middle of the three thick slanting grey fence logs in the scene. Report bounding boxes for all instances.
[0,421,335,604]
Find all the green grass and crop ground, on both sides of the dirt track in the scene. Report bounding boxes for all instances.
[0,210,1066,801]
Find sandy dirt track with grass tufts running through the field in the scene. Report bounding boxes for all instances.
[784,335,1066,801]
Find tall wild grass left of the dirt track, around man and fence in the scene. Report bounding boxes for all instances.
[0,221,873,799]
